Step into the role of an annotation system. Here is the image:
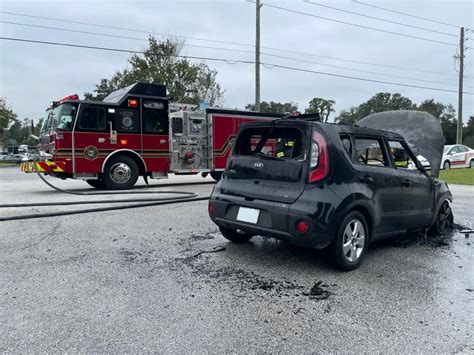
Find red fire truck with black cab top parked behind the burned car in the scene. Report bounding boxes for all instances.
[21,83,281,189]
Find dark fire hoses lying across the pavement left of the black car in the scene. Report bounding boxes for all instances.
[0,160,209,222]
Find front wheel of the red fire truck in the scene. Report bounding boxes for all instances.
[102,155,139,190]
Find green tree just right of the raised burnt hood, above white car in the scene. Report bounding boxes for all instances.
[416,99,457,144]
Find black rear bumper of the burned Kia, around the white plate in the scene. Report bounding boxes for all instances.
[209,194,333,249]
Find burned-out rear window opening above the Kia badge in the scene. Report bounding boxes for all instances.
[234,127,306,160]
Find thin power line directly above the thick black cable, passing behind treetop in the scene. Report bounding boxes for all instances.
[0,21,470,86]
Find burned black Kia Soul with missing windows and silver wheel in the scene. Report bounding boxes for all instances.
[209,113,453,270]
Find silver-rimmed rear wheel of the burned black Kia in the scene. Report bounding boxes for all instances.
[330,211,369,271]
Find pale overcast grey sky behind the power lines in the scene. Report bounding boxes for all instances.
[0,0,474,122]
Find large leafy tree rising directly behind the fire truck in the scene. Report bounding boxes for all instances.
[84,36,224,105]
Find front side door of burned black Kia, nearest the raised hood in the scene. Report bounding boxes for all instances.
[388,140,434,229]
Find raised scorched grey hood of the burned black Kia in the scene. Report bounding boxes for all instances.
[357,110,445,177]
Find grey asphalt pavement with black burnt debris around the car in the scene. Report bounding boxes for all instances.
[0,167,474,353]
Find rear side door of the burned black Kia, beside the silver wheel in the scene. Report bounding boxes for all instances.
[354,136,402,234]
